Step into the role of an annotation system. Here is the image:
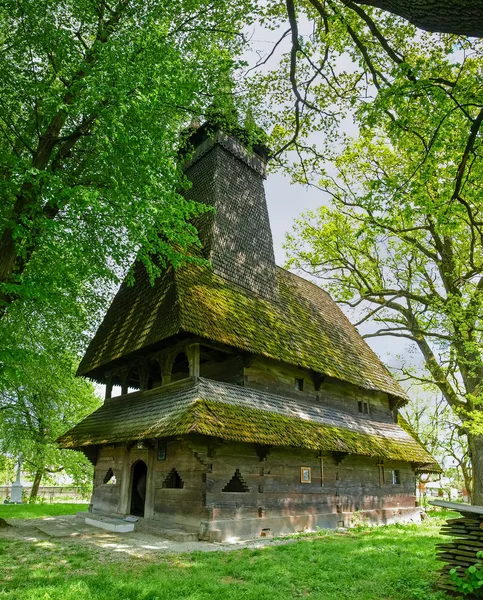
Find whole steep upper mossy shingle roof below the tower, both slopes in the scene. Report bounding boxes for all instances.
[79,264,406,398]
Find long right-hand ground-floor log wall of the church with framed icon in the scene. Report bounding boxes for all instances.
[206,442,415,519]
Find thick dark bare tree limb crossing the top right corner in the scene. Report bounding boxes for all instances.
[354,0,483,37]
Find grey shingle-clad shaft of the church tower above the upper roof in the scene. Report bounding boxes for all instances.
[186,144,278,299]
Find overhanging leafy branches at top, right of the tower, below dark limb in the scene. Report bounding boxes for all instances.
[249,0,482,164]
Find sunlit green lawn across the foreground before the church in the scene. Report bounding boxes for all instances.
[0,517,454,600]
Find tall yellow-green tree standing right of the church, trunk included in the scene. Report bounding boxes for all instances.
[288,112,483,504]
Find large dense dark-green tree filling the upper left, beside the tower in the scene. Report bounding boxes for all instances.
[0,0,252,326]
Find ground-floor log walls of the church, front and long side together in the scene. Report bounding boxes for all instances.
[93,435,415,539]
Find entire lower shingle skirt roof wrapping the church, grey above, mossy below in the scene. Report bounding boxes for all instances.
[58,378,439,471]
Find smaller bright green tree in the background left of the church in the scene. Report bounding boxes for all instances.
[0,352,100,501]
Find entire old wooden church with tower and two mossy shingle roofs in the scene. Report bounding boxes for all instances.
[59,125,439,541]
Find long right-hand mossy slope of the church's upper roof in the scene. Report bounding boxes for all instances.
[175,265,406,398]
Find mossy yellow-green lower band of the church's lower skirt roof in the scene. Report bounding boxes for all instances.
[61,399,439,471]
